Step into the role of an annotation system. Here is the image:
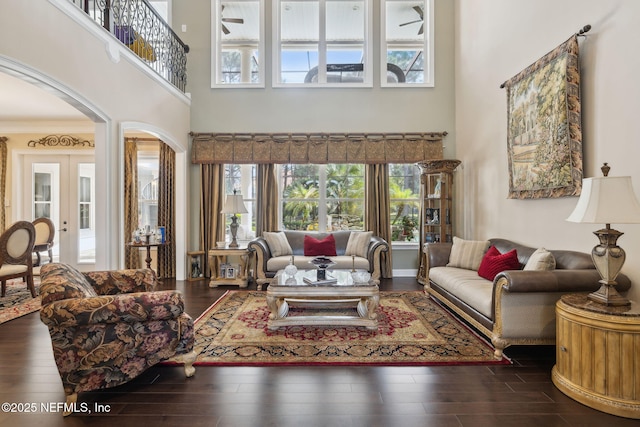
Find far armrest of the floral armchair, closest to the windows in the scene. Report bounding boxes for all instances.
[82,268,158,295]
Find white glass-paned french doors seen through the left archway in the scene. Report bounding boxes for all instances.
[22,154,96,271]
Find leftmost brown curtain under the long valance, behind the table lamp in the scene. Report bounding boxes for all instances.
[200,164,225,277]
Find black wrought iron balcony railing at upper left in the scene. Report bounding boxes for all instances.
[69,0,189,92]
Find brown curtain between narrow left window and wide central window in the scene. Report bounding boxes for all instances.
[256,164,280,236]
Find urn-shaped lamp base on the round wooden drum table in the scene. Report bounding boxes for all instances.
[588,224,631,306]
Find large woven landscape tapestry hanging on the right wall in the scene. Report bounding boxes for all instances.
[502,34,582,199]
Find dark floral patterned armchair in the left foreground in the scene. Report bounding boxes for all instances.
[40,263,195,415]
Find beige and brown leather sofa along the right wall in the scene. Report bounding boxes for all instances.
[423,238,631,358]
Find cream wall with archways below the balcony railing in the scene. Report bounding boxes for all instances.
[0,0,190,276]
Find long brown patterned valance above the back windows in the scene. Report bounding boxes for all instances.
[191,132,447,164]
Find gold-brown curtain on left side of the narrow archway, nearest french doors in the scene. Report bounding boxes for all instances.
[124,138,140,268]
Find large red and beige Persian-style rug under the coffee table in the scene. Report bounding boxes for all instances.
[174,291,511,366]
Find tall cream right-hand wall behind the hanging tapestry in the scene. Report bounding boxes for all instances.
[455,0,640,300]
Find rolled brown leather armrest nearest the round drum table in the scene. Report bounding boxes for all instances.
[494,269,631,293]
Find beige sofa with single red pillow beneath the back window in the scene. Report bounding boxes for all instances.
[248,230,389,289]
